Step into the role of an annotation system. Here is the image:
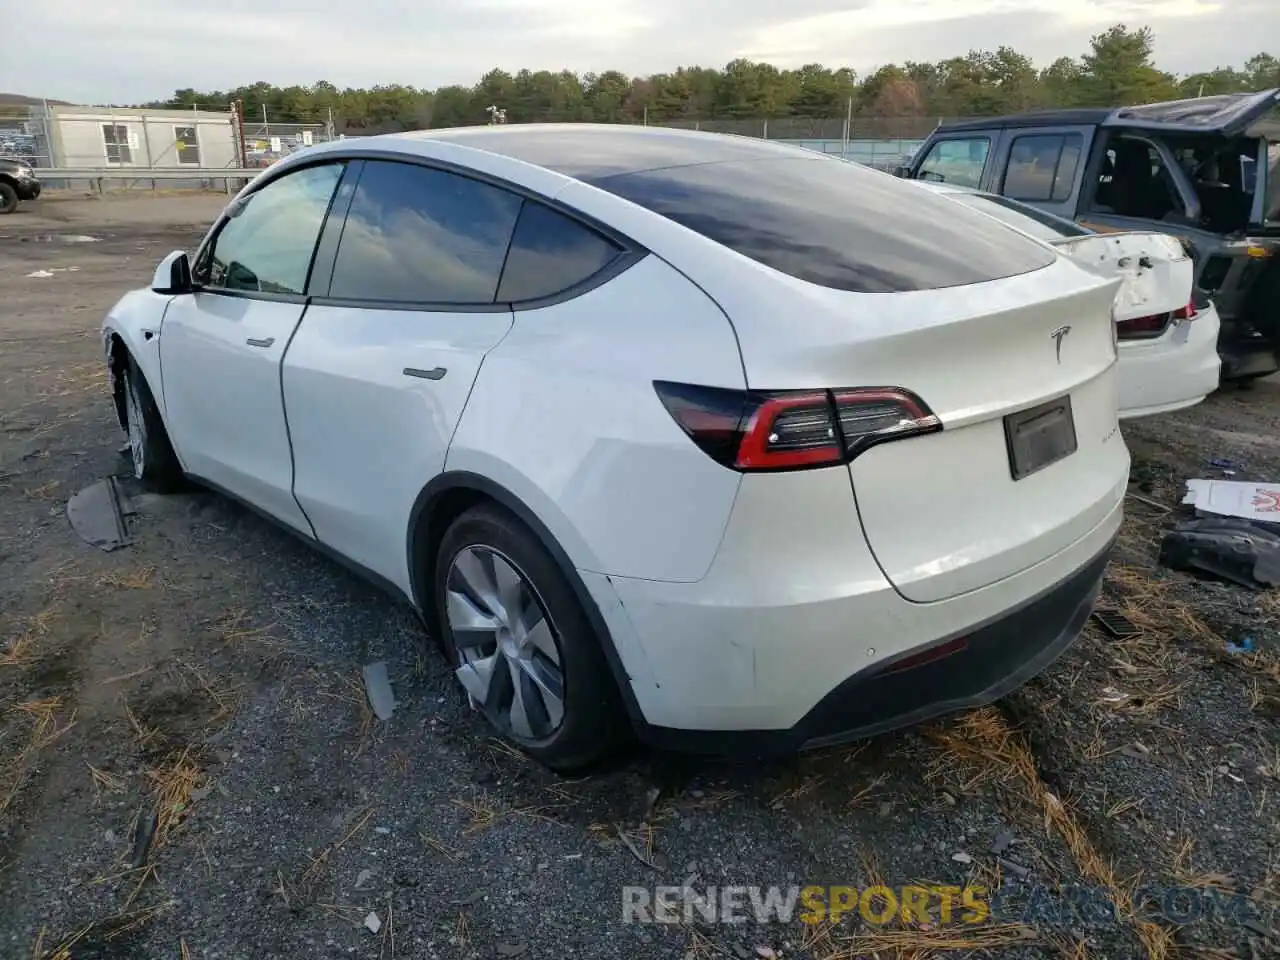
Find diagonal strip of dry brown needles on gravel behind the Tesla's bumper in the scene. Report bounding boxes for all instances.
[928,707,1174,960]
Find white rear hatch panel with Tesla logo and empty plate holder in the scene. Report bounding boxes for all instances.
[716,257,1129,603]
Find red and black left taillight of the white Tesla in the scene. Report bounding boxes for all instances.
[654,380,942,471]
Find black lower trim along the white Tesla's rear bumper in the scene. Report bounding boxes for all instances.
[640,544,1111,756]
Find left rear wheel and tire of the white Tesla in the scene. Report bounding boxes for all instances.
[434,504,626,773]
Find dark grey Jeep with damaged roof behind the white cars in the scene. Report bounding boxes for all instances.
[896,90,1280,379]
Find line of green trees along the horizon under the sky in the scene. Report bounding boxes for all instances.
[140,24,1280,136]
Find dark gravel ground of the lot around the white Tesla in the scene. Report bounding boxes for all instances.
[0,196,1280,960]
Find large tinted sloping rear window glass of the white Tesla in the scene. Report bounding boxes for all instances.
[593,156,1055,293]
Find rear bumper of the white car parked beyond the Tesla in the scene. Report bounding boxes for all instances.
[1120,305,1221,420]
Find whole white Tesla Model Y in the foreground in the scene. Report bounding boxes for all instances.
[102,125,1129,769]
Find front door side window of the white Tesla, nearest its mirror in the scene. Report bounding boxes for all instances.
[195,164,343,296]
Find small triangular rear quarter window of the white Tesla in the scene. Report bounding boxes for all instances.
[498,200,622,303]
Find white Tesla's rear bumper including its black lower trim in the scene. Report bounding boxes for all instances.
[584,470,1125,756]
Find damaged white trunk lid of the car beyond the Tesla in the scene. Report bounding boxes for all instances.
[1053,232,1196,323]
